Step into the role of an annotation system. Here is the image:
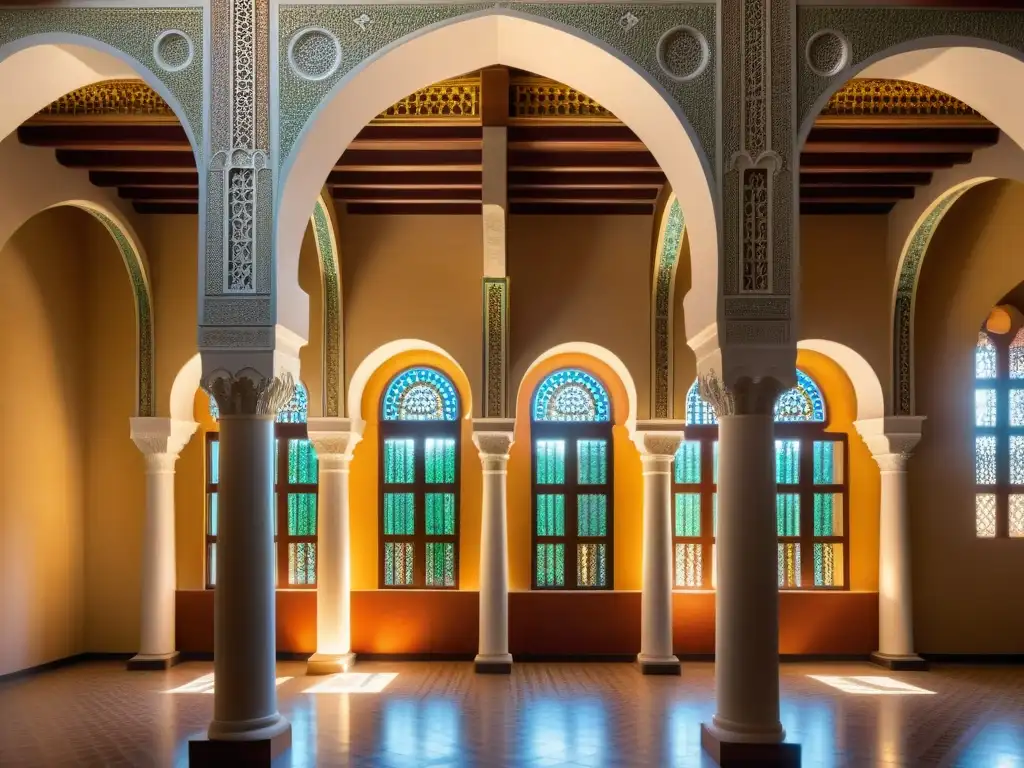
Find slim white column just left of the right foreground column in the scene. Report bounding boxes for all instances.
[634,421,683,675]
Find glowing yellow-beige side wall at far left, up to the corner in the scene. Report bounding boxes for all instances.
[0,208,88,675]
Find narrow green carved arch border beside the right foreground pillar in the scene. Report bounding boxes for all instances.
[651,193,685,419]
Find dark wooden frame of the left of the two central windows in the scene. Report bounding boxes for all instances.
[377,419,462,591]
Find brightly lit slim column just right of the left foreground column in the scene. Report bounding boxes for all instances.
[306,418,364,675]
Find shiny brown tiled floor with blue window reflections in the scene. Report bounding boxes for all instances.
[0,662,1024,768]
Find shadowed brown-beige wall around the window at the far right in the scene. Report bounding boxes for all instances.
[909,181,1024,653]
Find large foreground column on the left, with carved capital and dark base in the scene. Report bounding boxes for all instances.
[189,369,294,766]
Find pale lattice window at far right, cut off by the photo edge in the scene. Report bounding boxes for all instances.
[974,328,1024,539]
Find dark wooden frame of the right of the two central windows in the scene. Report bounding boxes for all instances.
[529,421,615,592]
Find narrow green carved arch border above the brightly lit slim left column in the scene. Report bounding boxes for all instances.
[312,194,345,417]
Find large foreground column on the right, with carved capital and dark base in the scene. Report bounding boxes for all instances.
[700,377,800,766]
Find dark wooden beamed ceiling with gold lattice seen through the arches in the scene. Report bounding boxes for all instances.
[18,68,999,215]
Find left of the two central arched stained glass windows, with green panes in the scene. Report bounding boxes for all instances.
[378,368,461,589]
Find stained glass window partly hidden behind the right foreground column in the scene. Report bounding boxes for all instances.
[673,370,847,589]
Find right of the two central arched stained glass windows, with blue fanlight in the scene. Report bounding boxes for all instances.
[530,369,613,590]
